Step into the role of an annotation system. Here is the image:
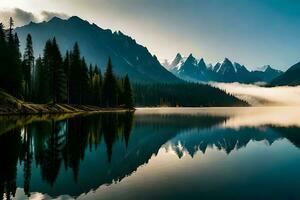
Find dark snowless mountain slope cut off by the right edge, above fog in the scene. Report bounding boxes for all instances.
[270,62,300,86]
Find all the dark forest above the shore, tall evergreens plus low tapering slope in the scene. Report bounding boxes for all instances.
[0,18,248,108]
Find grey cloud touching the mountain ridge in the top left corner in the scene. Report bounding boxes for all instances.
[0,8,69,27]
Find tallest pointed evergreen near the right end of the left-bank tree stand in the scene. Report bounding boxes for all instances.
[102,58,118,108]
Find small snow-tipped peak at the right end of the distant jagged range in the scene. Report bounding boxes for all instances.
[252,65,283,83]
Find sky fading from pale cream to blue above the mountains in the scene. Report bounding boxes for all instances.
[0,0,300,70]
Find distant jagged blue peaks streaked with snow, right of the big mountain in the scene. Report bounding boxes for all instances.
[164,53,283,83]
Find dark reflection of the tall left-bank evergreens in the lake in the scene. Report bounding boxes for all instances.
[0,112,133,199]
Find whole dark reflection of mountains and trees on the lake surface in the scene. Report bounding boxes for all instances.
[0,109,300,199]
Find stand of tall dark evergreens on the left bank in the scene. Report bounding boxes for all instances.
[0,18,133,108]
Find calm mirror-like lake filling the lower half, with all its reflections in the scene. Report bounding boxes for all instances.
[0,107,300,200]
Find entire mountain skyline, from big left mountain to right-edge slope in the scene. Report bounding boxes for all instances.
[16,16,300,86]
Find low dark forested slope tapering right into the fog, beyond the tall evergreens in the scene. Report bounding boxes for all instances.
[133,82,248,107]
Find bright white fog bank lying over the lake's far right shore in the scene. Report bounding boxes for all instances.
[211,83,300,106]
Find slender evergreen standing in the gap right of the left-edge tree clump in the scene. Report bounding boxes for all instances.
[23,34,34,100]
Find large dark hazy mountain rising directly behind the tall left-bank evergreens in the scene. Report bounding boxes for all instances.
[16,17,180,83]
